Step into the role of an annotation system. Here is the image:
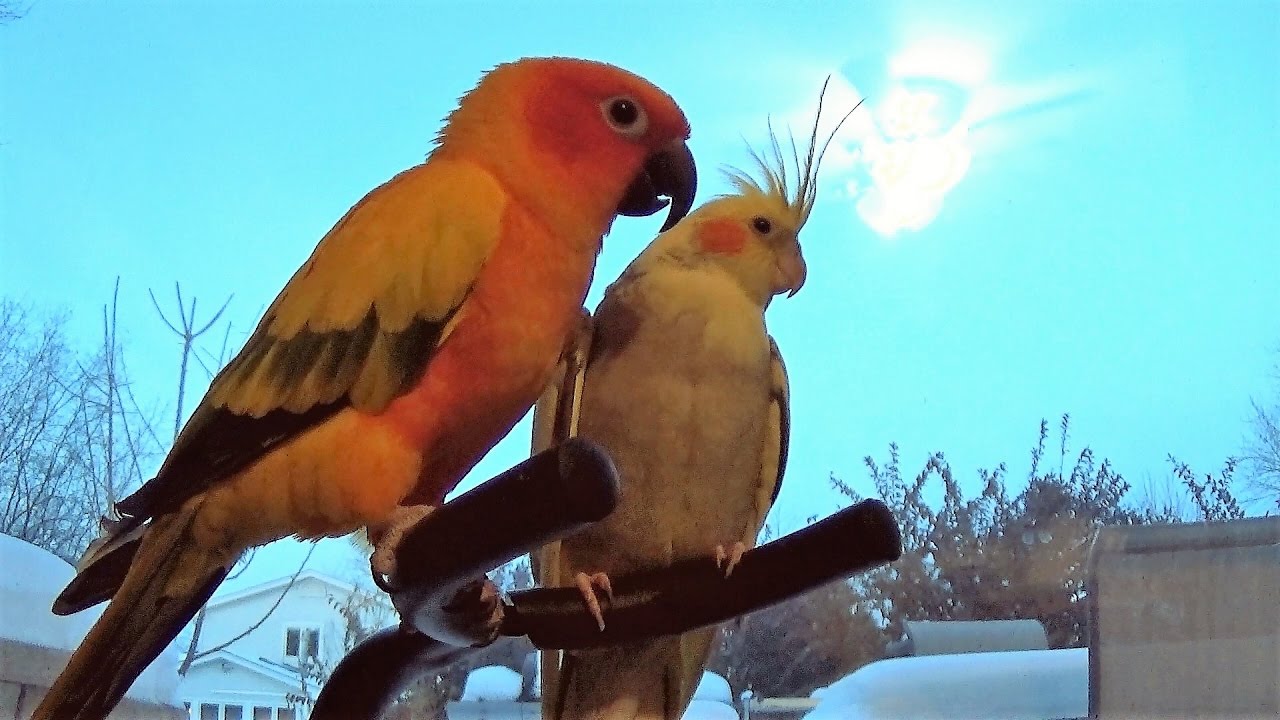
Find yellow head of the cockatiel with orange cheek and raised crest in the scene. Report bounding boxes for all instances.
[646,79,861,307]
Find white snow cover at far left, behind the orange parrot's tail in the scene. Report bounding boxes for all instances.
[0,534,179,705]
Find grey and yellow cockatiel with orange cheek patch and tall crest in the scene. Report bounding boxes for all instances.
[534,86,852,720]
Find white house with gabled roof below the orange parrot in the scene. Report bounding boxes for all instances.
[178,570,394,720]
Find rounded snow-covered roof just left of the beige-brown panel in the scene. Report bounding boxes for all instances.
[804,648,1089,720]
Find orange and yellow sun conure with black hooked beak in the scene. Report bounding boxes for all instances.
[35,58,696,720]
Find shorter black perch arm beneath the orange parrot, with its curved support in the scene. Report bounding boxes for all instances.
[311,438,618,720]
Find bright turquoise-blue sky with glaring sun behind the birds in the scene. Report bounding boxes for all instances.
[0,0,1280,584]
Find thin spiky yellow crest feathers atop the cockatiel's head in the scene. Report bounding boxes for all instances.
[726,76,863,232]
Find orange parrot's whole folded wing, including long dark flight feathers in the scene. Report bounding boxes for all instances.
[116,160,507,519]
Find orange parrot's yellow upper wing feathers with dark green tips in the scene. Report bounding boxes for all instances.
[209,159,506,418]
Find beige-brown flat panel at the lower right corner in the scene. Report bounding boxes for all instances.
[1089,518,1280,720]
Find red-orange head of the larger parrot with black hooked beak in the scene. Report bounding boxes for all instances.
[433,58,698,231]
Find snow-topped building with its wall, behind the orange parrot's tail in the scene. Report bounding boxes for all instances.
[0,534,184,720]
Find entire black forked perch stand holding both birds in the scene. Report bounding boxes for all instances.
[311,438,902,720]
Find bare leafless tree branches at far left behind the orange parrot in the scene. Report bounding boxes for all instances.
[0,288,156,561]
